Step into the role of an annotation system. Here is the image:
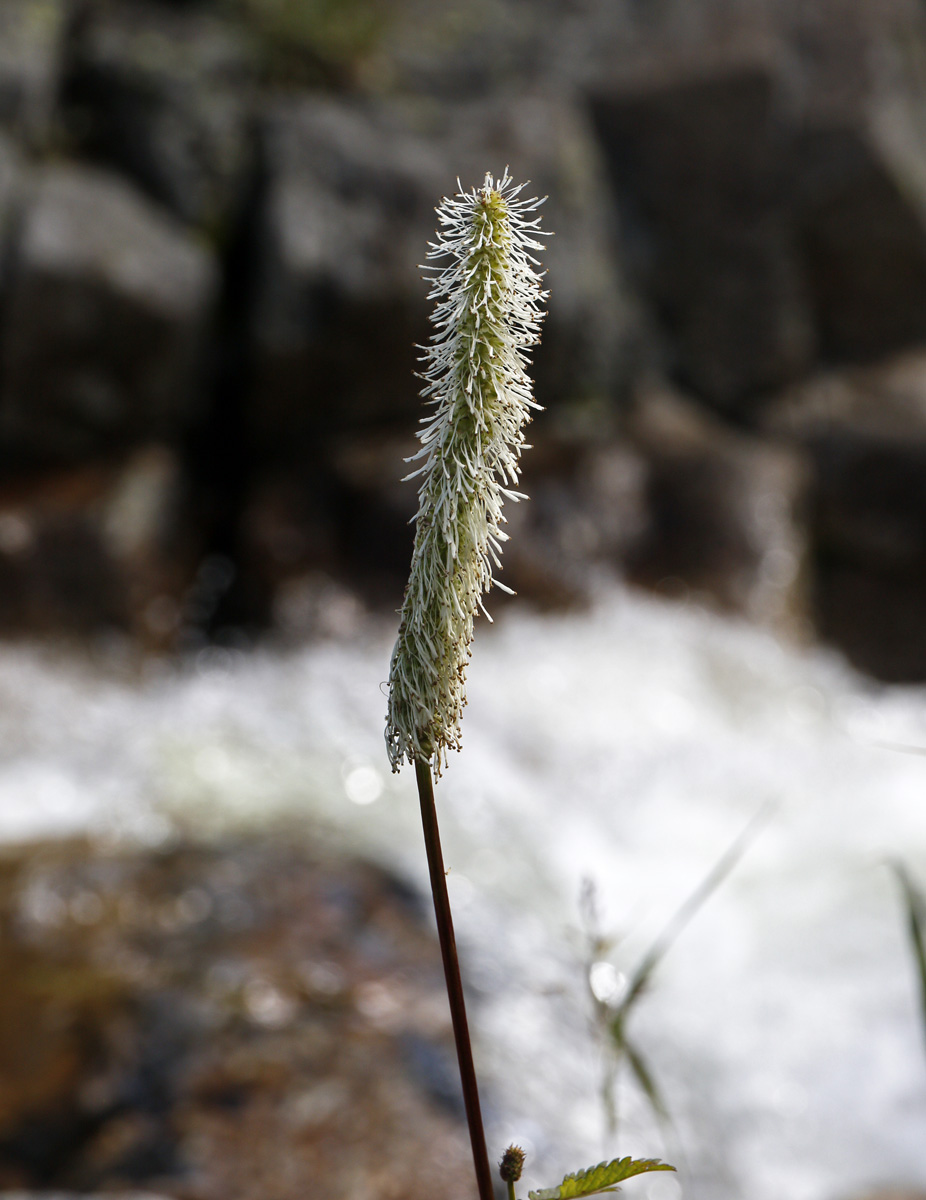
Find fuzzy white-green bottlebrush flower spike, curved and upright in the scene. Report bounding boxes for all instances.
[386,169,547,774]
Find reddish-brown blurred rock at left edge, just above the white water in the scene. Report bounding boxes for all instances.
[0,446,197,647]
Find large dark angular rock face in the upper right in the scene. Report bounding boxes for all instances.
[591,32,926,419]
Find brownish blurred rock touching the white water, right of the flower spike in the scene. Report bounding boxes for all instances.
[436,385,807,635]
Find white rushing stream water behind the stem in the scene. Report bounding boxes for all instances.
[0,588,926,1200]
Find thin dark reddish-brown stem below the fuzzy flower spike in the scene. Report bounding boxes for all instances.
[415,758,494,1200]
